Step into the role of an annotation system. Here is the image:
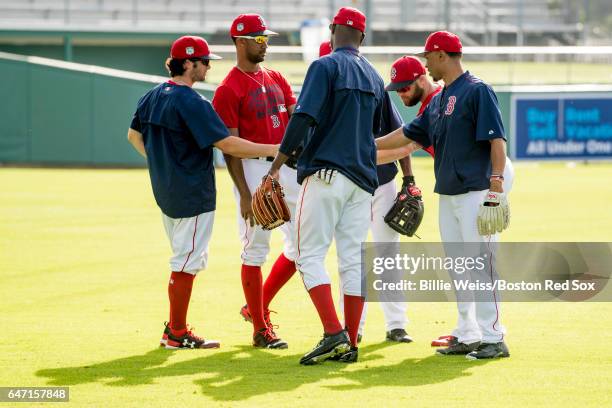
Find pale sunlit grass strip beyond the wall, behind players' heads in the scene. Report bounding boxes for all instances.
[207,55,612,85]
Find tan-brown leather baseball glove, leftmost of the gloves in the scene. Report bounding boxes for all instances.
[251,175,291,230]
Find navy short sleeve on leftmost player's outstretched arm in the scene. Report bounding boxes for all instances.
[179,91,229,149]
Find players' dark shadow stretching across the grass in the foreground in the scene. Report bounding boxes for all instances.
[36,342,484,401]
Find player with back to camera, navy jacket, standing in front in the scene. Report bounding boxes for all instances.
[269,7,385,365]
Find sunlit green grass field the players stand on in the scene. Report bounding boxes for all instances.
[0,158,612,408]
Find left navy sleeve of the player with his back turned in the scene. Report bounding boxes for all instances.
[295,60,331,123]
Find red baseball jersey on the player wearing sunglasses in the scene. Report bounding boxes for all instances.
[213,67,296,144]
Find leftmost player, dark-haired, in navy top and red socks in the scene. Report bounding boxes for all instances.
[128,36,278,349]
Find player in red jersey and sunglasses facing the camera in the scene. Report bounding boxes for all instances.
[213,14,299,348]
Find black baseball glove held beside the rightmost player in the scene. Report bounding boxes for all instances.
[384,185,425,237]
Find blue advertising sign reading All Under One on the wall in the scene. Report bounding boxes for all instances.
[512,93,612,160]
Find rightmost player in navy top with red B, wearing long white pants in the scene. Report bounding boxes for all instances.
[376,31,513,359]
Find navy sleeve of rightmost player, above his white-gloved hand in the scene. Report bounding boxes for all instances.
[474,85,506,141]
